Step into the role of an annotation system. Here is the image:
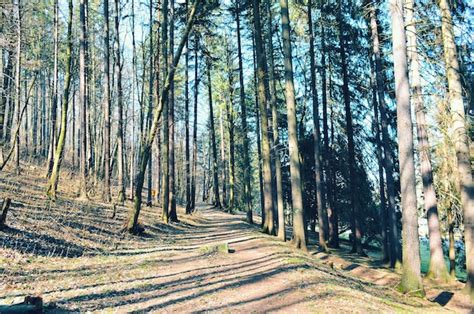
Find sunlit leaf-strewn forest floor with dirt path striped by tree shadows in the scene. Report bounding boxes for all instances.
[0,165,472,313]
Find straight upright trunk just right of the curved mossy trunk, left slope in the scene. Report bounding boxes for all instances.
[79,0,88,198]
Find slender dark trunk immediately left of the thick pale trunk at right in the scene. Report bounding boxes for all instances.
[370,2,401,268]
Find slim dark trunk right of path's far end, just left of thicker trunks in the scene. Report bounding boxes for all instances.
[235,0,253,223]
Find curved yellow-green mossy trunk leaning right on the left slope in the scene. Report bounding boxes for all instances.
[46,0,73,199]
